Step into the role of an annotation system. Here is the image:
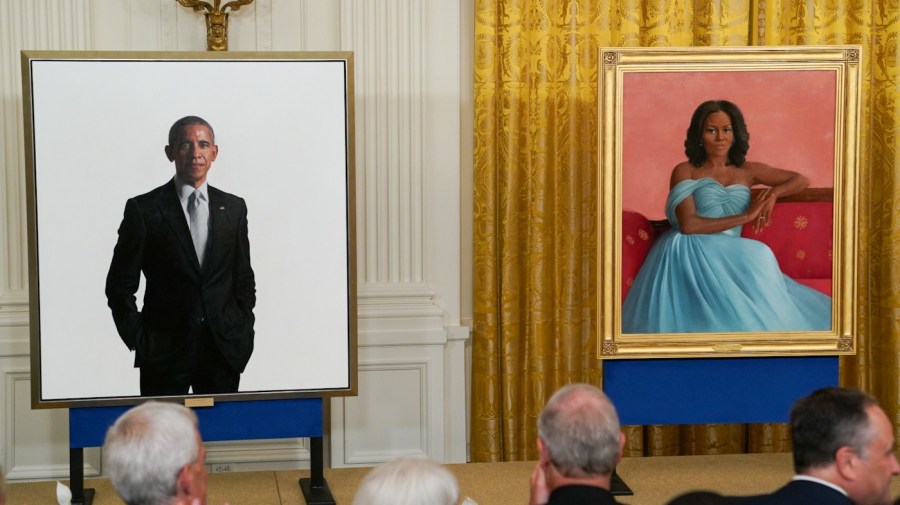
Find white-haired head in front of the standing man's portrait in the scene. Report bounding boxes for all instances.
[103,401,200,505]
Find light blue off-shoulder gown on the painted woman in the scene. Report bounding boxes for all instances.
[622,179,831,333]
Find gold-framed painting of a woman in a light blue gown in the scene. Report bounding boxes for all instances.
[598,46,861,359]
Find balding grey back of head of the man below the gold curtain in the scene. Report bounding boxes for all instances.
[538,384,621,478]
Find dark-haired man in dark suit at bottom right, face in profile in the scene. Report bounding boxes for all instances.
[671,388,900,505]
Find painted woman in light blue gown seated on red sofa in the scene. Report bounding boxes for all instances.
[622,100,831,333]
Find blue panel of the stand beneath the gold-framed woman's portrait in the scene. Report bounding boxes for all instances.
[603,356,838,425]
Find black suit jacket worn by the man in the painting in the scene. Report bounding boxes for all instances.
[106,180,256,372]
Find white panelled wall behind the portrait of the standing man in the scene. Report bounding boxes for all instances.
[0,0,472,480]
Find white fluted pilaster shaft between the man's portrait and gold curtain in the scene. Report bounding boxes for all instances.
[340,0,425,284]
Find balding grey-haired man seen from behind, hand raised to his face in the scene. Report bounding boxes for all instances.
[530,384,625,505]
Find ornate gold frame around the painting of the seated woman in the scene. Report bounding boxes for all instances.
[596,45,862,359]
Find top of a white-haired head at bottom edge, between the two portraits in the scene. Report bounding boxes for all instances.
[353,457,459,505]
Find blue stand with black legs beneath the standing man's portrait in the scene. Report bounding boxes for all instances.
[69,398,334,505]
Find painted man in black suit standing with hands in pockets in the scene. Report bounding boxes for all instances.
[106,116,256,396]
